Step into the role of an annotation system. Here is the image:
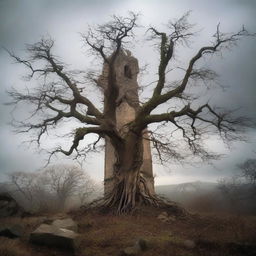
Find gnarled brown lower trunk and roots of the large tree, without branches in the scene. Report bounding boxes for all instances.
[105,132,157,214]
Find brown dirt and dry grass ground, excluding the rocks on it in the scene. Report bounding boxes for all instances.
[0,208,256,256]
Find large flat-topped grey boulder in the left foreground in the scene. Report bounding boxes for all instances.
[29,224,78,250]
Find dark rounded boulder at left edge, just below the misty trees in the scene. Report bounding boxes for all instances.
[0,193,25,218]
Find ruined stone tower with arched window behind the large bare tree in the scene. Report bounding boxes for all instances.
[98,50,154,193]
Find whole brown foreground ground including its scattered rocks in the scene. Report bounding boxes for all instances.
[0,204,256,256]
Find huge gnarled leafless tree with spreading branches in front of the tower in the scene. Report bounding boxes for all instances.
[9,13,255,213]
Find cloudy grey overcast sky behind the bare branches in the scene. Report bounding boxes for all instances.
[0,0,256,184]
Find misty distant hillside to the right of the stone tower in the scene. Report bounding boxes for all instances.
[156,181,256,215]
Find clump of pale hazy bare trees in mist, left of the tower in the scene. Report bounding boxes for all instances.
[8,165,95,211]
